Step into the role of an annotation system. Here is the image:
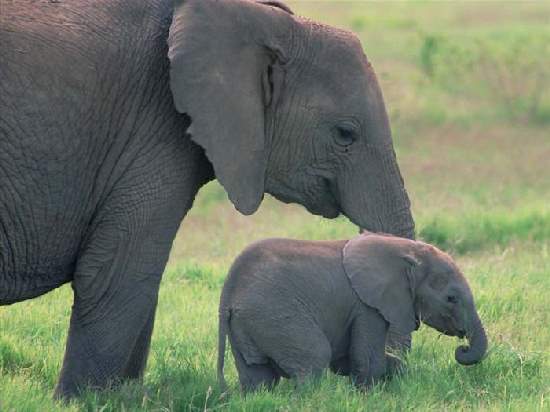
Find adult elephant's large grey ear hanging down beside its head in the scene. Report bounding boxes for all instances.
[168,0,294,214]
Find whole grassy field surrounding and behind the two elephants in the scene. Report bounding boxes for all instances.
[0,1,550,412]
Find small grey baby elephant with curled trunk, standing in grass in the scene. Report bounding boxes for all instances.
[218,233,487,391]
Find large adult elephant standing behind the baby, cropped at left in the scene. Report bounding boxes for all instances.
[0,0,414,396]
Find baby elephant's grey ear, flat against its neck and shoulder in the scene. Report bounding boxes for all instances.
[343,235,418,335]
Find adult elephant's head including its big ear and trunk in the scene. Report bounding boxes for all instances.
[168,0,414,237]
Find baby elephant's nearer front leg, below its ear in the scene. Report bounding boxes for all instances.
[349,306,388,388]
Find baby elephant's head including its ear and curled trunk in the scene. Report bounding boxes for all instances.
[343,233,487,365]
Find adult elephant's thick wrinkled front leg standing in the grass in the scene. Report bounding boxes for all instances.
[56,182,190,397]
